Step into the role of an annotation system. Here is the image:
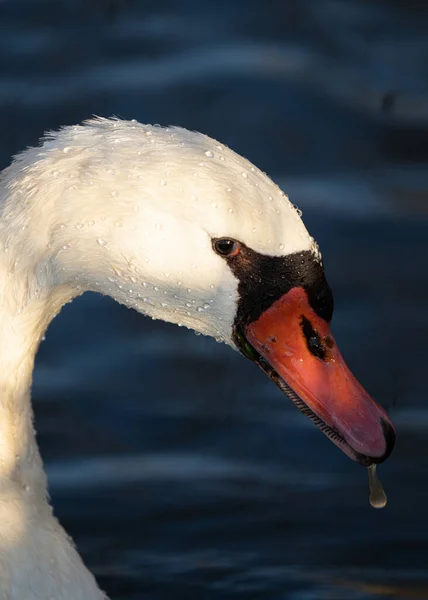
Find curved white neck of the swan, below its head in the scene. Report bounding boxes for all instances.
[0,261,106,600]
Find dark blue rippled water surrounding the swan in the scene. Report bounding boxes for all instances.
[0,0,428,600]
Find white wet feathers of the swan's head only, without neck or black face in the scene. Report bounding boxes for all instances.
[0,119,316,341]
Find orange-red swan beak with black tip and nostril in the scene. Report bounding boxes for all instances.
[245,287,395,466]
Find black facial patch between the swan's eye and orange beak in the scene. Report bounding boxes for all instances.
[213,240,333,327]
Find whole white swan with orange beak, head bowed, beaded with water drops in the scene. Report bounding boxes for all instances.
[0,118,395,600]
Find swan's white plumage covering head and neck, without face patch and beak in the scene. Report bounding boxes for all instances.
[0,119,318,600]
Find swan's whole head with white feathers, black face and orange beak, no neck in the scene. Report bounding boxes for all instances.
[1,119,395,466]
